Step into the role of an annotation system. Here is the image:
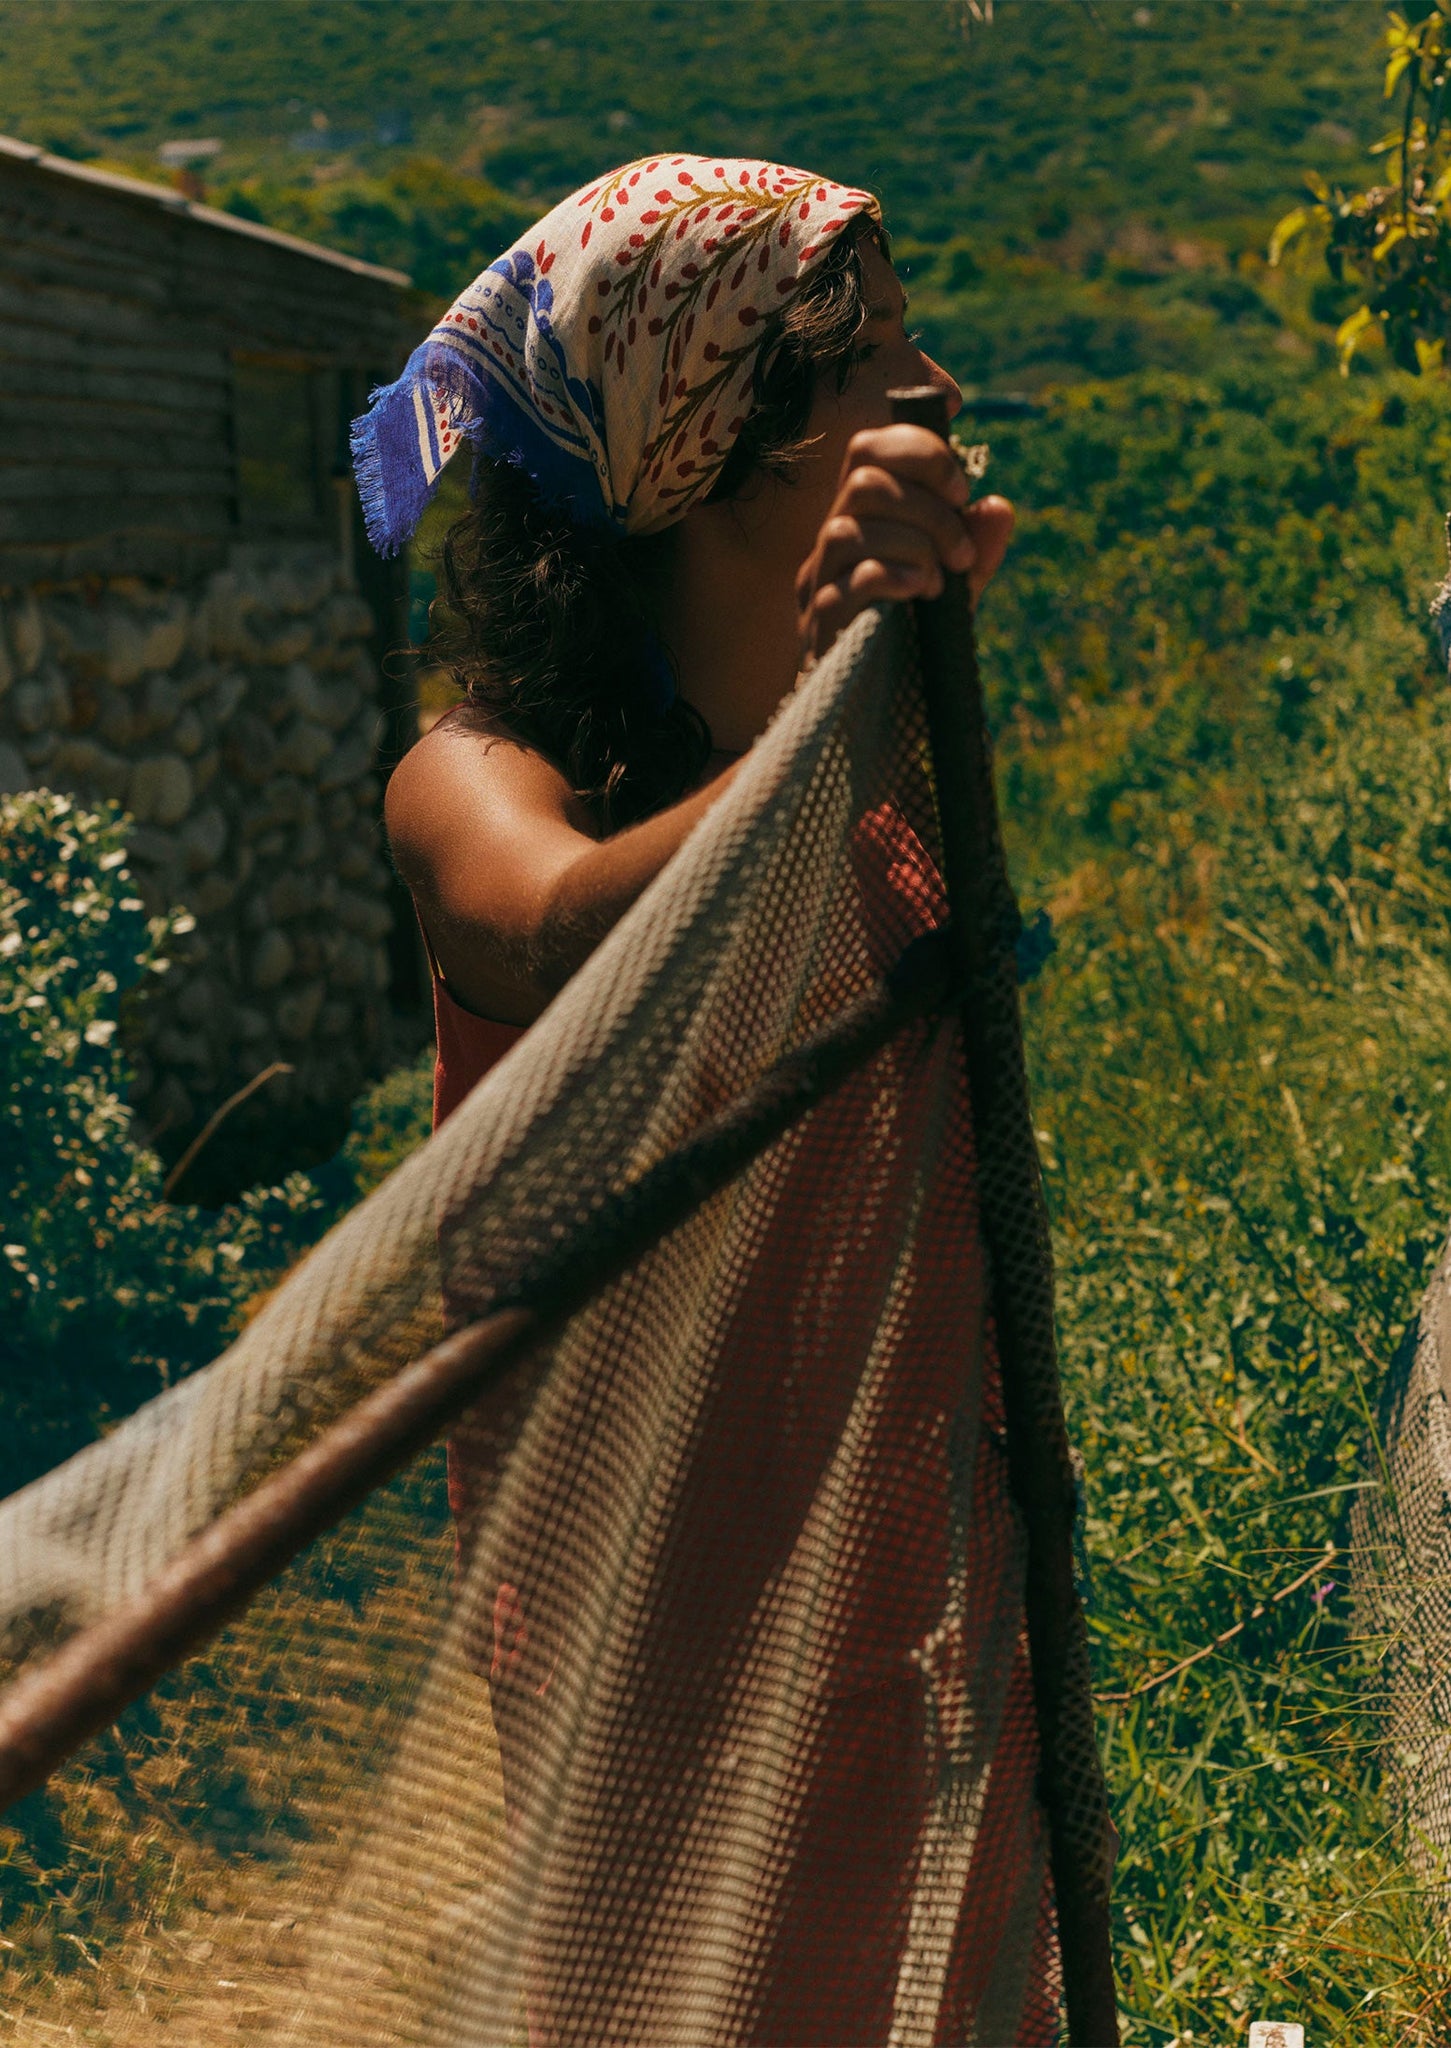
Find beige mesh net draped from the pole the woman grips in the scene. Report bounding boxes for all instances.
[0,614,1058,2048]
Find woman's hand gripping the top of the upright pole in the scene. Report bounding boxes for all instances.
[795,426,1012,668]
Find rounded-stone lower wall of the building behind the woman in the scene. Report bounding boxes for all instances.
[0,545,393,1192]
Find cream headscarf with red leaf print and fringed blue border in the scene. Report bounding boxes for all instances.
[353,156,879,555]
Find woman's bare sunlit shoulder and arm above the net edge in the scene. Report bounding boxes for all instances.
[387,719,738,1024]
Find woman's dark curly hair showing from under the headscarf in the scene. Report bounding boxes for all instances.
[434,225,885,831]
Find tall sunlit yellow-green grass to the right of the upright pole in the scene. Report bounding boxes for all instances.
[1031,614,1451,2048]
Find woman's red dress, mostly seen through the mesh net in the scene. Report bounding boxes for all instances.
[420,807,1058,2048]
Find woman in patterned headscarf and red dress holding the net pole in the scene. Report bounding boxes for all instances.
[355,156,1055,2048]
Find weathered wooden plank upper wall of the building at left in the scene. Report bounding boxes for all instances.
[0,152,413,586]
